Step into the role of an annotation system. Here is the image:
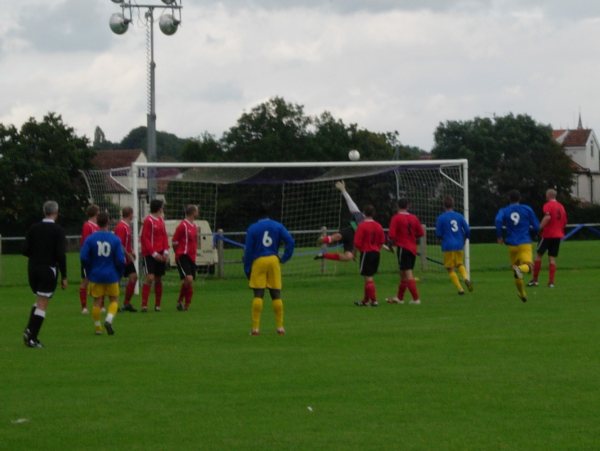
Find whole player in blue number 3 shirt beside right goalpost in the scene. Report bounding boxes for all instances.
[435,196,473,295]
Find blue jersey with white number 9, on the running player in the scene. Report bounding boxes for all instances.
[496,204,540,246]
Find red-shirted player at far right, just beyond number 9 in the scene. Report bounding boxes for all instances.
[527,189,567,288]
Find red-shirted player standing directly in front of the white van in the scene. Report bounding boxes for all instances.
[171,205,199,311]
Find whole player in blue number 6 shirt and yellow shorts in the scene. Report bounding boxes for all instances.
[244,205,294,335]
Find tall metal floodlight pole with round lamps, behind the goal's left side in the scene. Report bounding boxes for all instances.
[109,0,183,200]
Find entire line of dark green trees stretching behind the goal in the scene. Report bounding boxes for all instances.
[0,97,585,236]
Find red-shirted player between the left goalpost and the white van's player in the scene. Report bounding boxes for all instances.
[140,199,169,312]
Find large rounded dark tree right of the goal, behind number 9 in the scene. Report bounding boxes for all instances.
[432,114,573,225]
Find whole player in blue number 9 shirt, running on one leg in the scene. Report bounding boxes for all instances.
[496,190,540,302]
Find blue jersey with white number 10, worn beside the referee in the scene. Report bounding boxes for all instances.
[79,230,125,283]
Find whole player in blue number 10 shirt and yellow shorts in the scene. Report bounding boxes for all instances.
[79,212,125,335]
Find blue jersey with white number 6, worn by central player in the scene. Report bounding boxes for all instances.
[244,218,294,275]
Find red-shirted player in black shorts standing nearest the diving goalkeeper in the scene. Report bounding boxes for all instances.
[354,205,385,307]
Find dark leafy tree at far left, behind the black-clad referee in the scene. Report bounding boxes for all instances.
[0,113,94,235]
